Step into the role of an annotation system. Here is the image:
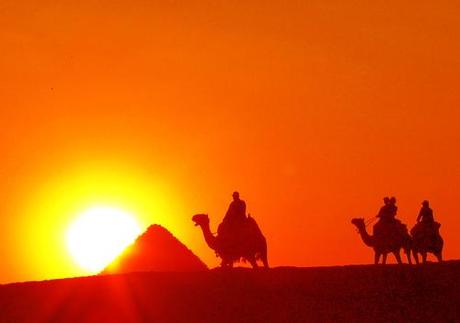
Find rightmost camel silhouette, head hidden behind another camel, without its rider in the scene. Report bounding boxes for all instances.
[411,222,444,264]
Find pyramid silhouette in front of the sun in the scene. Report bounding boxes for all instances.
[101,224,208,274]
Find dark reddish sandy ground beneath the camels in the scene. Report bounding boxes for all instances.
[0,261,460,323]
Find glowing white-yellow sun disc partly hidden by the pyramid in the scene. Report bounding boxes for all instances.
[66,207,141,273]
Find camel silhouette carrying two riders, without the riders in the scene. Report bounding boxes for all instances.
[351,218,412,264]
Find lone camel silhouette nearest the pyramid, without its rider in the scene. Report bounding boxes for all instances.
[192,214,268,268]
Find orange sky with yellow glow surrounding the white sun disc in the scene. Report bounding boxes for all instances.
[0,0,460,283]
